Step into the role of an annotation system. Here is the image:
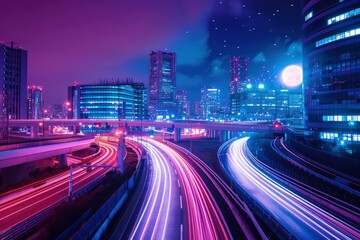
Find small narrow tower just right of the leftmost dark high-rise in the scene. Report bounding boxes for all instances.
[28,86,44,119]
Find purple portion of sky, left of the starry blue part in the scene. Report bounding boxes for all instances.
[0,0,211,104]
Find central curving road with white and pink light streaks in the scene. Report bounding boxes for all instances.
[111,139,266,239]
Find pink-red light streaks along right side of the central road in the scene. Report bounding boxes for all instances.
[149,140,231,239]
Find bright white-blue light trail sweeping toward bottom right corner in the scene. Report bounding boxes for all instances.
[226,138,360,239]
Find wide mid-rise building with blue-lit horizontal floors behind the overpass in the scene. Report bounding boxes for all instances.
[68,80,147,120]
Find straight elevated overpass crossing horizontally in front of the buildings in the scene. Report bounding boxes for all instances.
[0,119,287,141]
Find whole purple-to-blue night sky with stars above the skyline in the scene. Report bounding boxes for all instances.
[0,0,302,105]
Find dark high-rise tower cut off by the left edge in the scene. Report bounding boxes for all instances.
[0,42,27,120]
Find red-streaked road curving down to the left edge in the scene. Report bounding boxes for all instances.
[0,143,117,233]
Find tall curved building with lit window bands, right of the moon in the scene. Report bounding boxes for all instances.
[302,0,360,156]
